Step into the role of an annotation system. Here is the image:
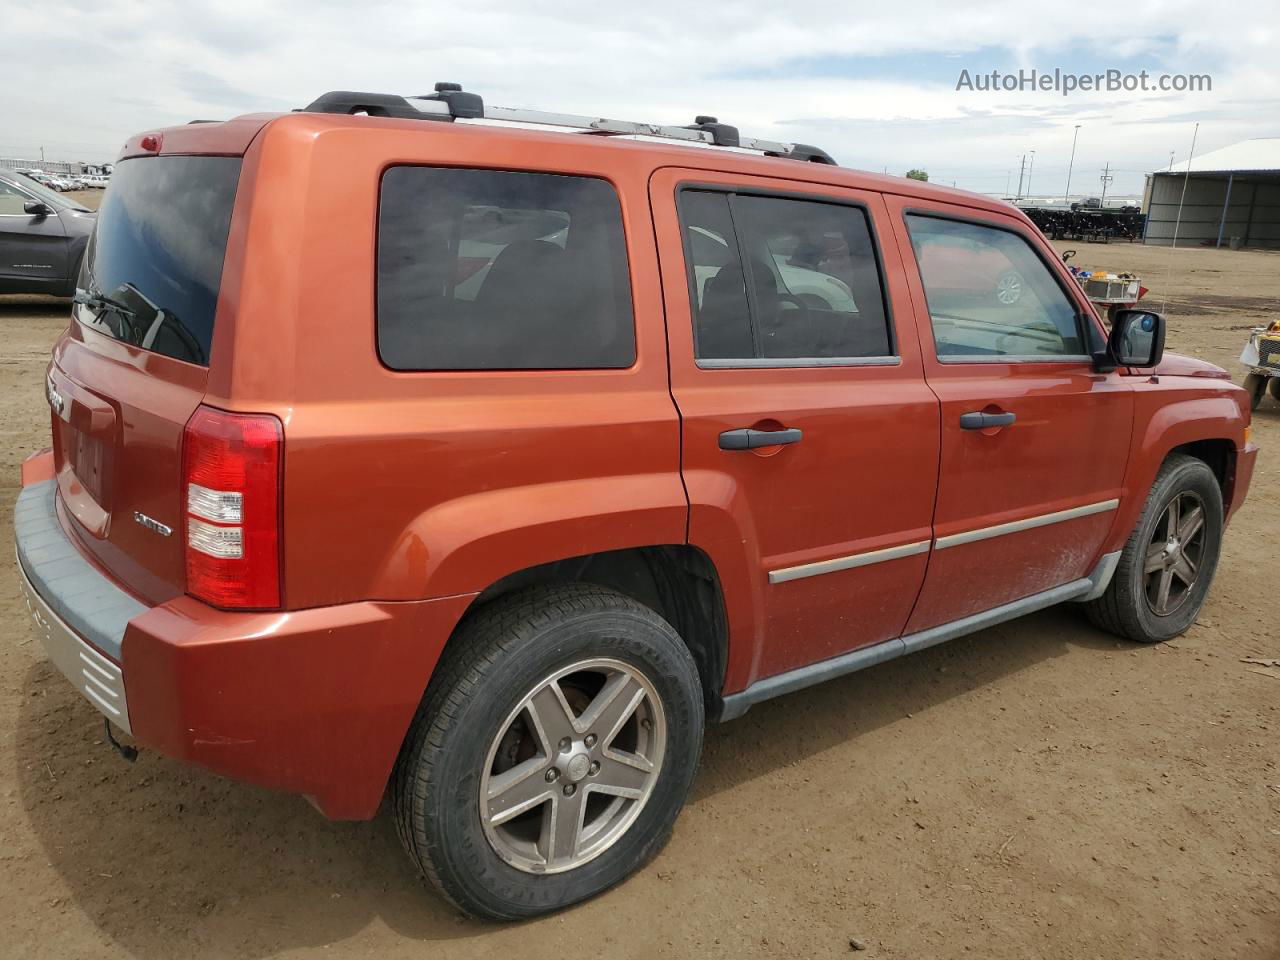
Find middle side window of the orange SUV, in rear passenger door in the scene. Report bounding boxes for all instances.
[680,191,892,360]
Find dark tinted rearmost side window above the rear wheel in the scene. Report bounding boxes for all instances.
[378,166,636,370]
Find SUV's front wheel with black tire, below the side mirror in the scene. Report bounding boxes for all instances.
[1085,454,1222,644]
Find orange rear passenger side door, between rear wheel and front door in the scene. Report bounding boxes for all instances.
[650,169,938,692]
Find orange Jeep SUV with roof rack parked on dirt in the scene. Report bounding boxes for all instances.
[14,84,1256,919]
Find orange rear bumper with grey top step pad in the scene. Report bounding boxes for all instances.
[14,465,472,819]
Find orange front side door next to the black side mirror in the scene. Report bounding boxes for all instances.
[886,197,1133,632]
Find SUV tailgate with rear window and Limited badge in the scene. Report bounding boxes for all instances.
[46,156,241,603]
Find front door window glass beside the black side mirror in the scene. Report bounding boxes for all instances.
[906,216,1088,360]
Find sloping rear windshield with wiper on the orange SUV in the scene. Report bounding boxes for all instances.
[77,156,241,365]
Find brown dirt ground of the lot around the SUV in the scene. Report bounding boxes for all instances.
[0,195,1280,960]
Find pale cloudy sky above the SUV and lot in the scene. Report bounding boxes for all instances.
[0,0,1280,196]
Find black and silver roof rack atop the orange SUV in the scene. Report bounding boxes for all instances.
[302,83,836,164]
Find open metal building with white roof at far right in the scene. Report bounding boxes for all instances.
[1143,137,1280,250]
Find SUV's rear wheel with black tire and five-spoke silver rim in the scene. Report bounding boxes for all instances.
[392,584,704,920]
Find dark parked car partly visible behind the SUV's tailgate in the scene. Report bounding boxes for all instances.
[0,170,97,297]
